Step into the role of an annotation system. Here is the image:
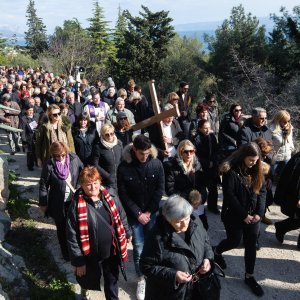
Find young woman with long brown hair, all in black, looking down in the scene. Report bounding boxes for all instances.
[214,142,266,296]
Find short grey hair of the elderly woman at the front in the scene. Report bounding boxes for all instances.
[162,195,193,222]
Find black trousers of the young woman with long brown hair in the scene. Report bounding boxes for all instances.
[216,222,260,274]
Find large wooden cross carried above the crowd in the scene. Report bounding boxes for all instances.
[131,80,180,150]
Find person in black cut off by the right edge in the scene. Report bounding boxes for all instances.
[274,152,300,249]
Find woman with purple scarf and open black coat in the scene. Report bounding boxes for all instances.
[39,141,83,261]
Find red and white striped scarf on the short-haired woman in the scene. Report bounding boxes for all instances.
[77,186,128,262]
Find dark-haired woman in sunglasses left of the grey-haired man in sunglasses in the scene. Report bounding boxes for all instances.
[219,103,242,159]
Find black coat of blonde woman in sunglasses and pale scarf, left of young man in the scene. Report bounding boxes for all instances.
[93,140,123,188]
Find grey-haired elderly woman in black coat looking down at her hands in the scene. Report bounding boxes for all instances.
[140,195,213,300]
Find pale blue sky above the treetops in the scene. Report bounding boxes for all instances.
[0,0,299,34]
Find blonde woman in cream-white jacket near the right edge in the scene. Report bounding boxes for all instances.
[269,110,294,176]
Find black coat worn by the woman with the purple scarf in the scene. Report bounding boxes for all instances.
[39,153,83,220]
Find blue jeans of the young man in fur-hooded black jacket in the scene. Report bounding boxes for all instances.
[128,213,156,277]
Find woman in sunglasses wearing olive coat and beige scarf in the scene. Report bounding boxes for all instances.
[35,104,75,167]
